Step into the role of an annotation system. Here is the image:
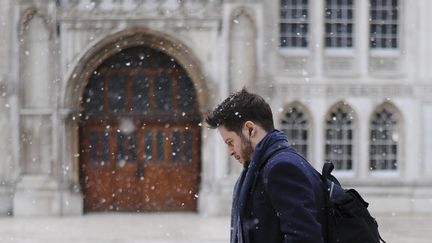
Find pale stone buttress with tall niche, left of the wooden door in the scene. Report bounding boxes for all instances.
[13,2,61,216]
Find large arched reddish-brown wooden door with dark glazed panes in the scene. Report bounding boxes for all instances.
[80,46,201,212]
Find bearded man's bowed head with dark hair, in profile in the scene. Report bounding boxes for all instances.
[206,89,274,165]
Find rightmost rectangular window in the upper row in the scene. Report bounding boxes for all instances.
[369,0,399,49]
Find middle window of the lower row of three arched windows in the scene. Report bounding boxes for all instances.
[325,103,354,170]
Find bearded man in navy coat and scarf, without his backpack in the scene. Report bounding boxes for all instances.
[206,89,326,243]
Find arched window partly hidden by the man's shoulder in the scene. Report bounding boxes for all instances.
[281,105,310,158]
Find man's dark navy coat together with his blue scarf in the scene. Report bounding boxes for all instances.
[231,130,326,243]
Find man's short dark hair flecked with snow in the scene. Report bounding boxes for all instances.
[206,88,274,135]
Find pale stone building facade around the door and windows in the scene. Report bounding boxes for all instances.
[0,0,432,216]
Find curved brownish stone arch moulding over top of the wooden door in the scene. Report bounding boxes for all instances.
[61,27,210,113]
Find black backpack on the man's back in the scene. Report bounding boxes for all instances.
[322,162,385,243]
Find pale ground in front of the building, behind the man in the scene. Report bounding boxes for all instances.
[0,213,432,243]
